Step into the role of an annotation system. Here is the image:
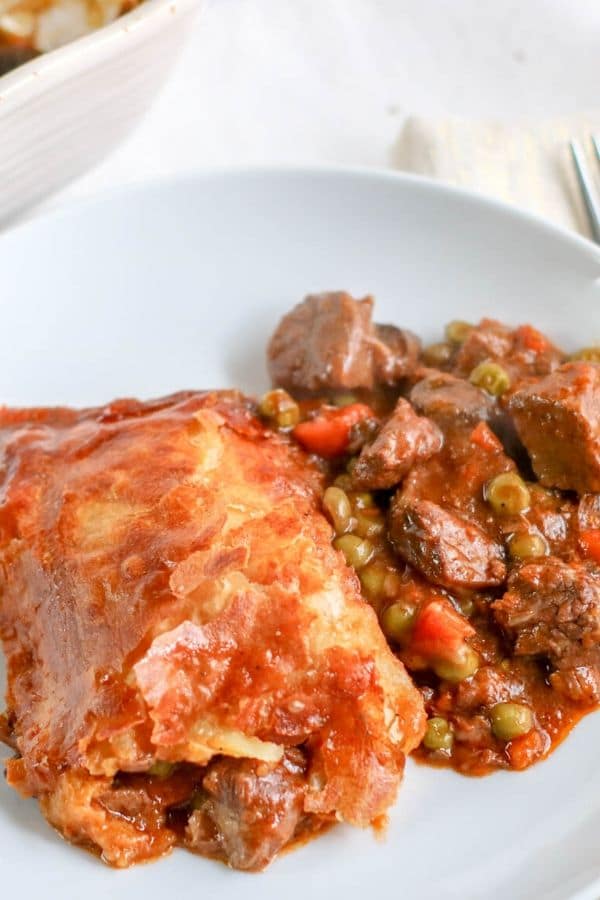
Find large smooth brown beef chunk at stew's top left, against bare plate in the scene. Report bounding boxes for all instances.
[267,291,420,393]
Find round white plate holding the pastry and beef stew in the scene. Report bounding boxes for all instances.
[0,171,600,900]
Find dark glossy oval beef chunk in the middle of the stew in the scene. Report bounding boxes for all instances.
[390,495,506,590]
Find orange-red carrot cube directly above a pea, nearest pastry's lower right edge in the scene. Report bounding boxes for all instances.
[410,598,475,661]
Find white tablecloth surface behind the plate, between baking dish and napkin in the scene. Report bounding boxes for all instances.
[41,0,600,213]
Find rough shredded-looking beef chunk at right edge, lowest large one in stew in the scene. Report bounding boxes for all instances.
[493,557,600,703]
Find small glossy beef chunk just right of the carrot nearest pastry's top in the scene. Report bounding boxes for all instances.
[352,398,444,490]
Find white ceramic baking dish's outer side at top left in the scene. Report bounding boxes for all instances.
[0,0,201,224]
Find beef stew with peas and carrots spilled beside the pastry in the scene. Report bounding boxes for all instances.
[262,293,600,775]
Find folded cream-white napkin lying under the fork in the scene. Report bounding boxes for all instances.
[392,113,600,237]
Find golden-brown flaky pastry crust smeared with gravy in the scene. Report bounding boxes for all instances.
[0,392,424,865]
